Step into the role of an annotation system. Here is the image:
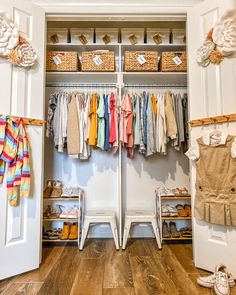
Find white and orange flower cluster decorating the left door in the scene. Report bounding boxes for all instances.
[0,13,37,68]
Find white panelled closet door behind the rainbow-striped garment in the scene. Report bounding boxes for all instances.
[0,0,45,280]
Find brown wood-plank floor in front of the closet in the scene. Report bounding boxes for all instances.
[0,239,236,295]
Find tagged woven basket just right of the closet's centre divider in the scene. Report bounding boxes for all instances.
[124,51,158,72]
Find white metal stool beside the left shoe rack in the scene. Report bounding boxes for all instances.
[79,210,120,250]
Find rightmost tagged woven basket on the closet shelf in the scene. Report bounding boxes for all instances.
[160,51,187,72]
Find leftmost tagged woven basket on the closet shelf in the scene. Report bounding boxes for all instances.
[46,51,79,72]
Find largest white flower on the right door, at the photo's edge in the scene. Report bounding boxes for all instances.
[212,9,236,56]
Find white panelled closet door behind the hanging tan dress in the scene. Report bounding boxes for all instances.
[188,0,236,278]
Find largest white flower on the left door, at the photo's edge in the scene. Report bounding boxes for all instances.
[0,15,19,56]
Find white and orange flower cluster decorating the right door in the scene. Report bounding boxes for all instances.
[197,9,236,67]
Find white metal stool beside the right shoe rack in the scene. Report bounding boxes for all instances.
[122,210,161,250]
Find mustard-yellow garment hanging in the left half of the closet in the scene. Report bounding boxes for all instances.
[88,93,98,146]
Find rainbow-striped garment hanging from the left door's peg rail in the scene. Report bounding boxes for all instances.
[0,116,30,206]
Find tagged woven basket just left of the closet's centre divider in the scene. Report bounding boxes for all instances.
[82,50,115,72]
